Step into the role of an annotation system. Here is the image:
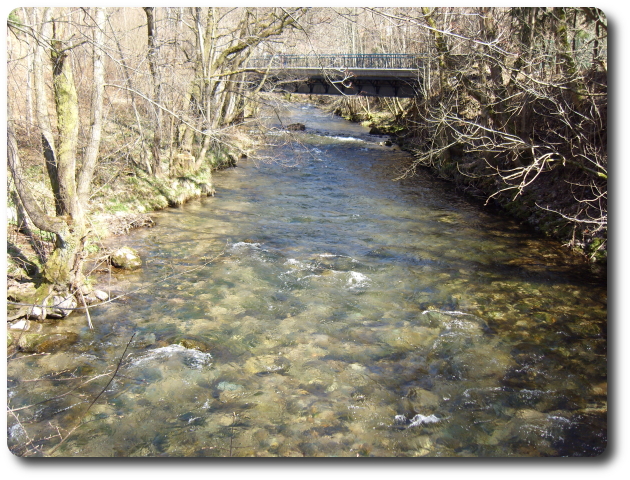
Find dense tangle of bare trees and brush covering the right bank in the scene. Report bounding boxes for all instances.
[373,7,607,253]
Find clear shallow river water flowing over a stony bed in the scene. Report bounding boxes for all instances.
[8,106,607,457]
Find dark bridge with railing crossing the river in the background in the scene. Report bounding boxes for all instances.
[247,53,424,98]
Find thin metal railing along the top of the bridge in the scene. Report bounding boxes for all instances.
[249,53,423,69]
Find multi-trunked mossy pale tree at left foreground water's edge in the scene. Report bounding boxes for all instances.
[7,7,105,292]
